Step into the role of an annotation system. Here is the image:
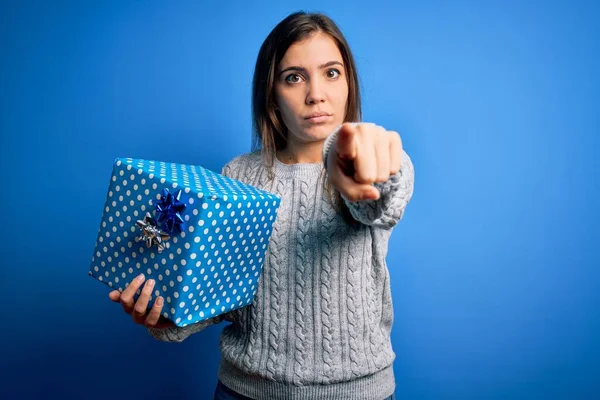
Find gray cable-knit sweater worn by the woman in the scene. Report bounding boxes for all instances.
[149,134,414,400]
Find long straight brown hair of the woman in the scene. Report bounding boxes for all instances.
[252,11,362,225]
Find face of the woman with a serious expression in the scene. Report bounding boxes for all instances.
[275,32,348,143]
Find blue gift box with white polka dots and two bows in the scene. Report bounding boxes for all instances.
[89,158,281,327]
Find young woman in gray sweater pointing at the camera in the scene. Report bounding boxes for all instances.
[110,12,414,400]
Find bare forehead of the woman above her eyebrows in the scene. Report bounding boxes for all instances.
[280,32,343,68]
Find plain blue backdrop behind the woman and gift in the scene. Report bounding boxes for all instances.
[0,0,600,399]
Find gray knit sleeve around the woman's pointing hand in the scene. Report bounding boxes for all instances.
[323,126,415,229]
